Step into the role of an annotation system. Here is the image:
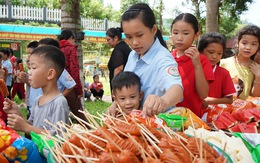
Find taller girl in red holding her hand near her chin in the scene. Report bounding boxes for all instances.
[171,13,214,117]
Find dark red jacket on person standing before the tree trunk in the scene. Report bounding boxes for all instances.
[60,40,83,95]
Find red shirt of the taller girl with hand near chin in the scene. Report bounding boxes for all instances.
[172,49,214,117]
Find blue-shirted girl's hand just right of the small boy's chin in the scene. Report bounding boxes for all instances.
[141,95,167,116]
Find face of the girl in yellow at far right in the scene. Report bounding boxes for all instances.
[238,35,259,58]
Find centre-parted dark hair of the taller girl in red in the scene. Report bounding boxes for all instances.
[171,13,199,34]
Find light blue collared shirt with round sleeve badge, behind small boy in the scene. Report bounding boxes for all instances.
[124,38,182,105]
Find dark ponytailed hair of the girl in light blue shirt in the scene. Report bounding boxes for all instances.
[121,3,167,48]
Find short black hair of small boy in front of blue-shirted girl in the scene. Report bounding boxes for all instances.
[112,71,141,93]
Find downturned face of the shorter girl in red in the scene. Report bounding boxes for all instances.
[202,43,223,65]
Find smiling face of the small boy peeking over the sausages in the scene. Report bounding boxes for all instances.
[113,86,143,114]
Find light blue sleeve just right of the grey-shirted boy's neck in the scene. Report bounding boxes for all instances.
[57,69,76,93]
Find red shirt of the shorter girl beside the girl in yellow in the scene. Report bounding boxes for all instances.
[208,65,236,98]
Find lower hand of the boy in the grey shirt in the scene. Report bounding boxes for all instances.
[7,114,27,131]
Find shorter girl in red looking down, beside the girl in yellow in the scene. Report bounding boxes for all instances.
[198,32,236,108]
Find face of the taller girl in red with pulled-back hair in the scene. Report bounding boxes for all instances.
[171,20,199,52]
